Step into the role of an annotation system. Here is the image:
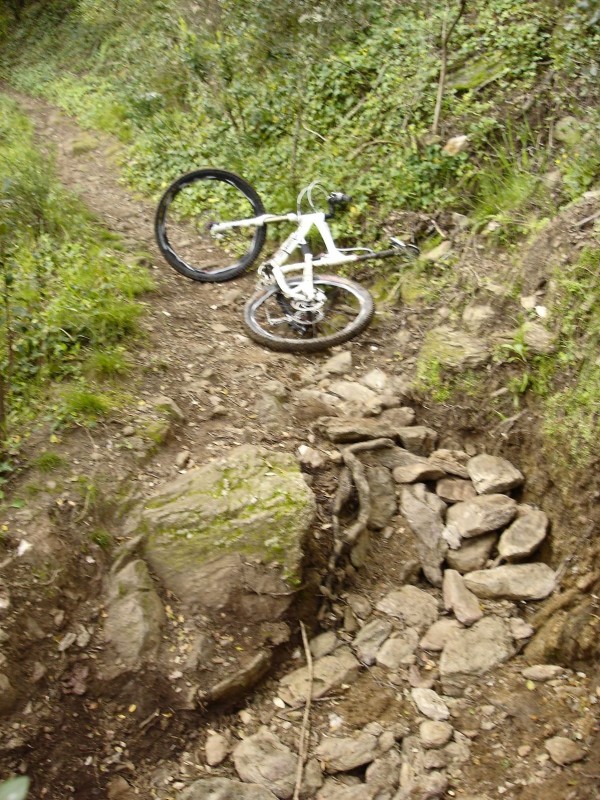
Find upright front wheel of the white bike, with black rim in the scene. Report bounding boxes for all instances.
[154,169,265,283]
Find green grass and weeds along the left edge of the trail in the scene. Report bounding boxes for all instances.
[0,98,152,469]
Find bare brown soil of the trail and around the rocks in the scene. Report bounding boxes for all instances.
[0,97,600,800]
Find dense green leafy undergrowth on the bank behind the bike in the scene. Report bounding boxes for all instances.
[3,0,600,239]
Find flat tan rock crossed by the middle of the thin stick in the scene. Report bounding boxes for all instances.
[279,647,360,706]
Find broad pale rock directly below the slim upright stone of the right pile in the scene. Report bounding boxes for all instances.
[440,616,515,695]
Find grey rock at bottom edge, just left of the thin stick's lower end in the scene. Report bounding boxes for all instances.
[233,727,298,800]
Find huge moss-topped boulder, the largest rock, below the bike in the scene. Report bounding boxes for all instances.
[134,445,315,621]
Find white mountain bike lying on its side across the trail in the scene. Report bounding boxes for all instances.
[155,169,419,353]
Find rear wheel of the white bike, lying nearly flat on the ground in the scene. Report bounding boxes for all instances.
[244,275,375,353]
